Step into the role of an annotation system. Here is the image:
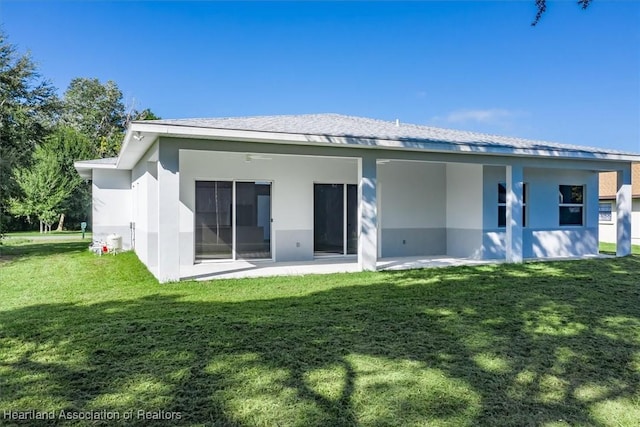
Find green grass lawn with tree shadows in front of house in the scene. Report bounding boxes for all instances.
[0,241,640,426]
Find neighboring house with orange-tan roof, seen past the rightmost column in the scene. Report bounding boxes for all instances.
[599,163,640,245]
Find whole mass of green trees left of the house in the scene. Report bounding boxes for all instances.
[0,31,159,236]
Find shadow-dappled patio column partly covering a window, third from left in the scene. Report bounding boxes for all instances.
[506,165,524,262]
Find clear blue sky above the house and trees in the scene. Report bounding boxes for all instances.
[0,0,640,152]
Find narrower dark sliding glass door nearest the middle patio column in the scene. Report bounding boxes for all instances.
[313,184,358,256]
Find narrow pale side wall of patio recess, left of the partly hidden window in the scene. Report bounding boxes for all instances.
[446,163,483,258]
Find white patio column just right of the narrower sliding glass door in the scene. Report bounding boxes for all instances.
[358,153,378,271]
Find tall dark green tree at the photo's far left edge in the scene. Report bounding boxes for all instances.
[0,31,60,233]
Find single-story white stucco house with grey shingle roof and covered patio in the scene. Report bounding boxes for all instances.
[75,114,640,282]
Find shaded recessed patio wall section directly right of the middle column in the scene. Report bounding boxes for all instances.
[378,162,447,258]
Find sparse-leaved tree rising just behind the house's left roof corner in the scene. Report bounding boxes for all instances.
[61,77,126,157]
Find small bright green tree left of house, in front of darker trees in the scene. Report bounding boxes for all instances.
[9,144,73,232]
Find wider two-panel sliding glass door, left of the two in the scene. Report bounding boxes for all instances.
[195,181,271,260]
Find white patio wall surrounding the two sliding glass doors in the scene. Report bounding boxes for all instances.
[179,150,358,266]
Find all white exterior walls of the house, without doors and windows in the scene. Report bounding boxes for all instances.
[93,138,624,280]
